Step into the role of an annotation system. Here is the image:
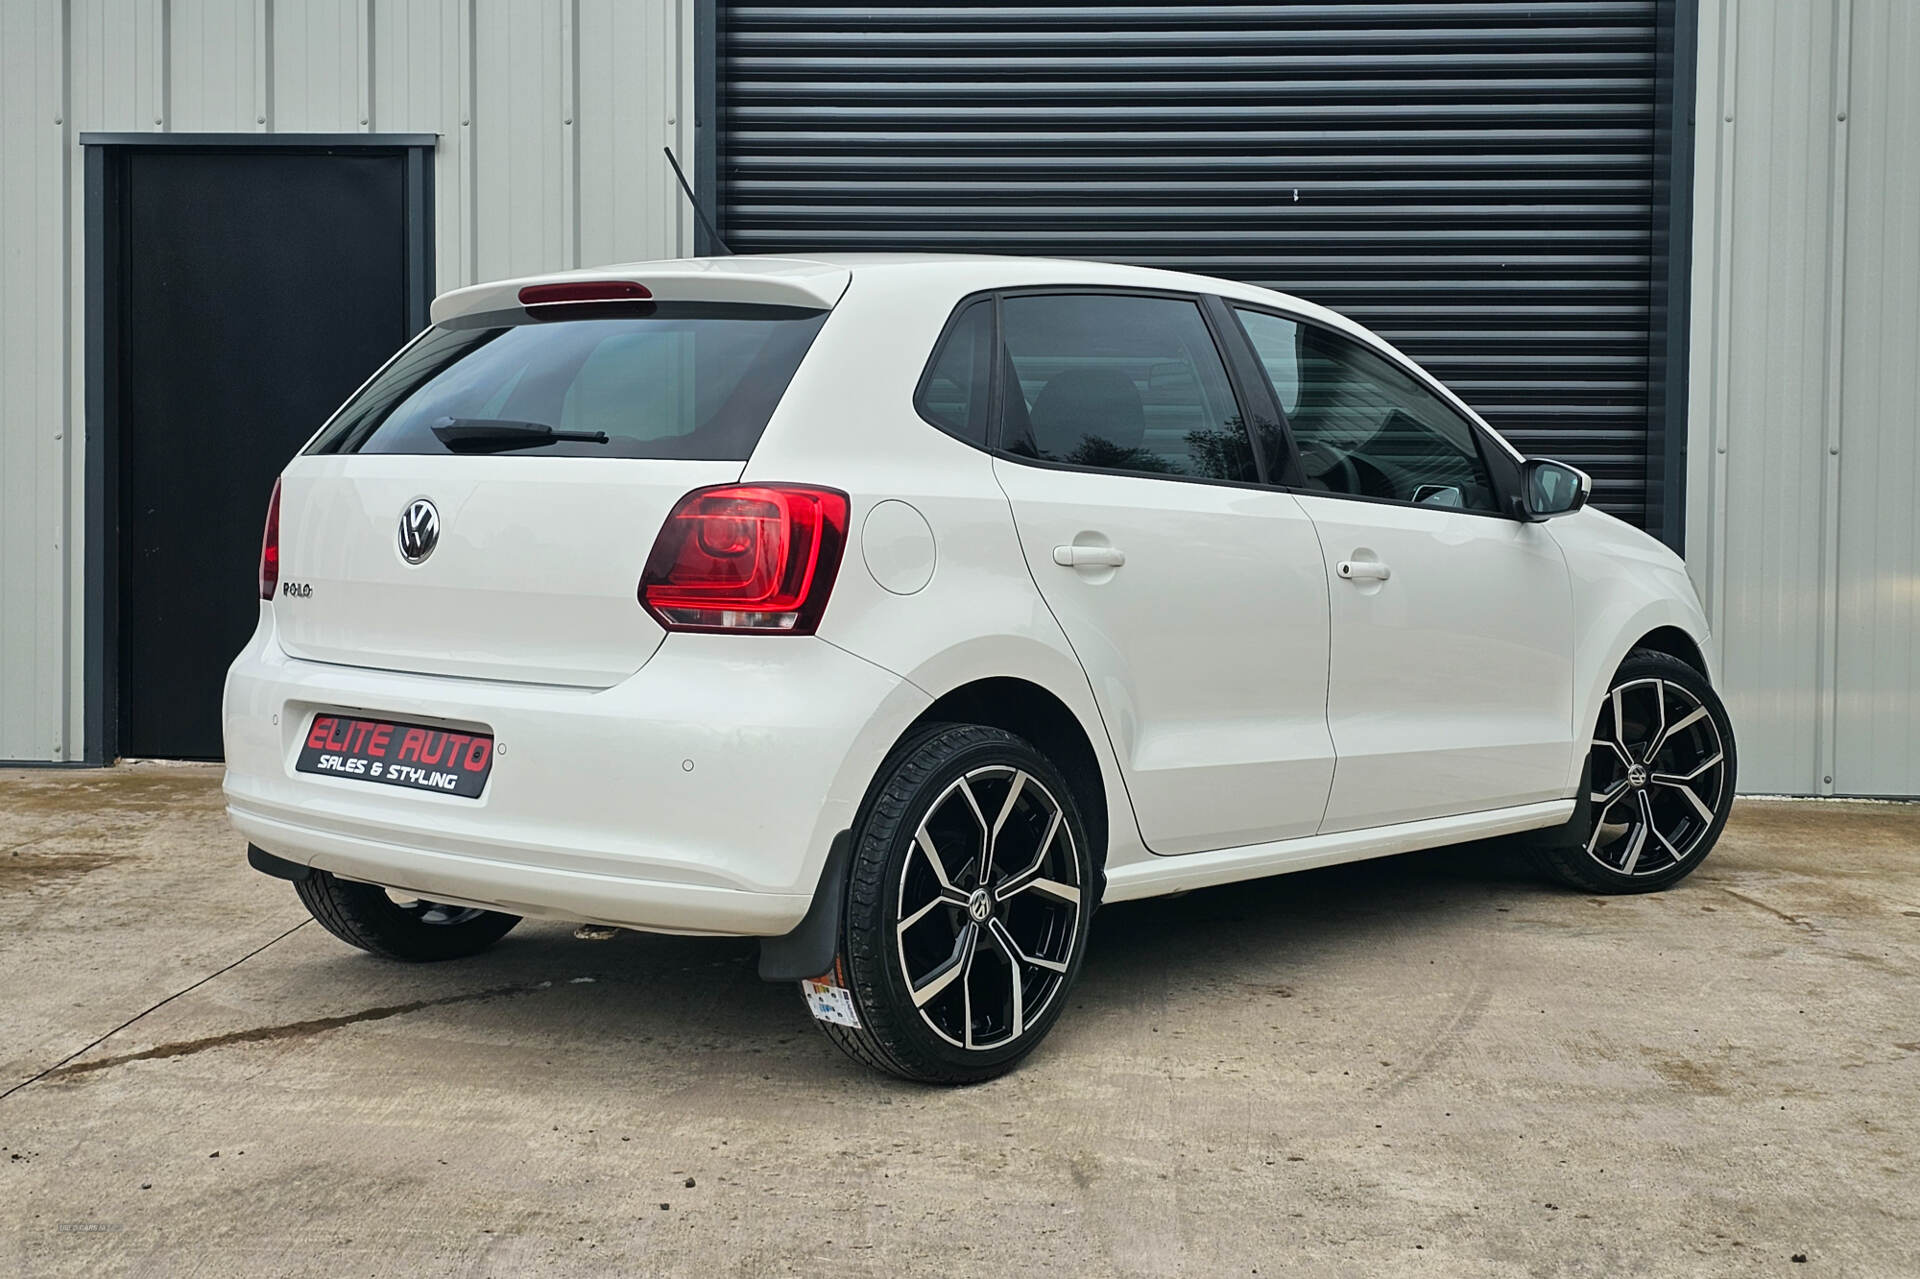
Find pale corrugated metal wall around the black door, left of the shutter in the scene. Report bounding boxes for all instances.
[0,0,693,760]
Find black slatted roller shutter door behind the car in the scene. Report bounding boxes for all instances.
[716,0,1657,522]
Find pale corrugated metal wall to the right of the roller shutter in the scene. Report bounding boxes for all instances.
[1688,0,1920,795]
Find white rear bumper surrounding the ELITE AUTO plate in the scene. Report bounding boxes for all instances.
[225,605,927,937]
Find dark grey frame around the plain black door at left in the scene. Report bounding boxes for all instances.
[79,133,440,766]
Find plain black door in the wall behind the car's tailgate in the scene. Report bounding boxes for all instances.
[109,148,409,759]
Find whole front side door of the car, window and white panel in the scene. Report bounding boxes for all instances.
[1236,309,1574,832]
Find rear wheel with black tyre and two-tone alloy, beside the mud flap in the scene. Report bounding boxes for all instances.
[820,724,1098,1083]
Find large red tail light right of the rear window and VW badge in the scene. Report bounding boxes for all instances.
[639,484,847,636]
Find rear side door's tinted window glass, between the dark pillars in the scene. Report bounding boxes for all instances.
[1000,294,1258,484]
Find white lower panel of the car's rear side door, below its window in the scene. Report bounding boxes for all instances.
[995,459,1332,853]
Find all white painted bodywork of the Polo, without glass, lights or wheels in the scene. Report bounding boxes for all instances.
[227,255,1705,935]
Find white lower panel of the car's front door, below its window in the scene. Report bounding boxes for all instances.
[1300,495,1590,832]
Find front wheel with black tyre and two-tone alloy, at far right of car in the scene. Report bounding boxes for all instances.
[1534,651,1736,893]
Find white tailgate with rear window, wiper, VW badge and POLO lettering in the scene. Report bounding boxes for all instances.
[275,302,828,688]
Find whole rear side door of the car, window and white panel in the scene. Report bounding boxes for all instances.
[995,294,1332,853]
